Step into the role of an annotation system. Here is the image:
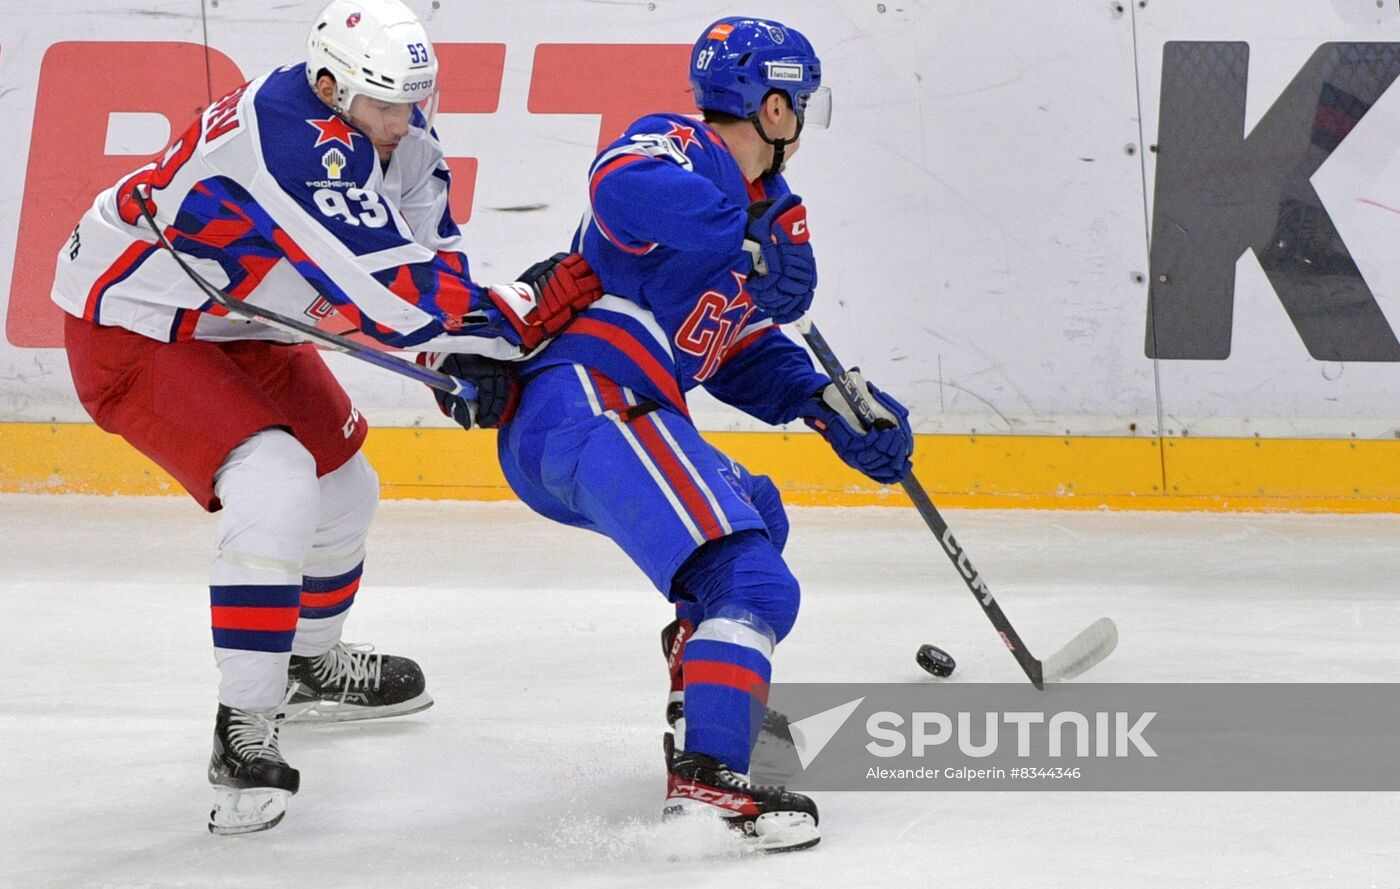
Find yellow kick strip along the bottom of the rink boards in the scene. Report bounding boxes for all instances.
[0,423,1400,512]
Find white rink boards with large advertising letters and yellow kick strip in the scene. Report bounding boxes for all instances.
[0,0,1400,510]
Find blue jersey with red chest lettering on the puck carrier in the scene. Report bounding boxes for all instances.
[525,115,829,424]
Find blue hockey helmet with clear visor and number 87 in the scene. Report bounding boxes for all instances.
[690,17,832,126]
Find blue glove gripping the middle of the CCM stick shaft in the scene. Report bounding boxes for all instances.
[802,367,914,484]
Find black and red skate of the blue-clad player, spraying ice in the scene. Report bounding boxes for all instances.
[661,735,822,853]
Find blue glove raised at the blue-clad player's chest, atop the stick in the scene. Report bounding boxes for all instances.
[745,195,816,323]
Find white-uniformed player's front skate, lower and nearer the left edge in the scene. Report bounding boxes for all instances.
[209,704,301,834]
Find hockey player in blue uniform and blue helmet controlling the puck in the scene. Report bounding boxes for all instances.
[440,18,913,851]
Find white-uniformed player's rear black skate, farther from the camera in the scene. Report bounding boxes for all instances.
[281,643,433,722]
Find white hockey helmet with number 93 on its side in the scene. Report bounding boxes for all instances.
[307,0,438,126]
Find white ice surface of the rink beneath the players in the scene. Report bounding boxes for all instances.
[0,496,1400,889]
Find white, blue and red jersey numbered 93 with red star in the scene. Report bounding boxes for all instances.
[53,64,533,358]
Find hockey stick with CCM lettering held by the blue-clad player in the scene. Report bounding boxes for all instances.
[792,315,1119,689]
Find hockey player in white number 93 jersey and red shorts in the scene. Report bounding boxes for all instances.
[53,0,602,833]
